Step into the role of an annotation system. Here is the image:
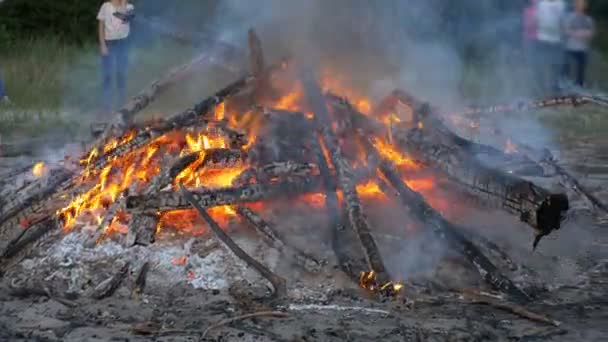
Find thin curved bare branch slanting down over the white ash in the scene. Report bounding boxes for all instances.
[179,183,287,298]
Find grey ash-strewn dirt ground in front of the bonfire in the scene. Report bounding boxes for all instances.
[0,116,608,341]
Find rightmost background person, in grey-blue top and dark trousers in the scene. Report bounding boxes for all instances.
[563,0,595,87]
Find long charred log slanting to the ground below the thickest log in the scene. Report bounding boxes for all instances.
[360,137,529,301]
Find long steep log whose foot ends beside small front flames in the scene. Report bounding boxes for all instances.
[302,72,390,286]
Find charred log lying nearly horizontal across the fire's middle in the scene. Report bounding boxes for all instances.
[127,177,330,213]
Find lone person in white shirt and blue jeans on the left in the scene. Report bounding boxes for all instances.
[97,0,134,112]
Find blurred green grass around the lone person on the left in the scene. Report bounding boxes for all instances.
[0,39,218,137]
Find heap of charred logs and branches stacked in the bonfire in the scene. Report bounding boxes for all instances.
[0,31,604,302]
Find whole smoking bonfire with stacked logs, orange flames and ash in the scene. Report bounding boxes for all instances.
[0,31,604,342]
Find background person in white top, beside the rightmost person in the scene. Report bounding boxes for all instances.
[536,0,566,91]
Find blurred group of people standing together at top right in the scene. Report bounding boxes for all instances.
[523,0,595,92]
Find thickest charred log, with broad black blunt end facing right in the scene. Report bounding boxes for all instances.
[394,107,569,246]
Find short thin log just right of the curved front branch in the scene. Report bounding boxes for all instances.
[236,206,321,273]
